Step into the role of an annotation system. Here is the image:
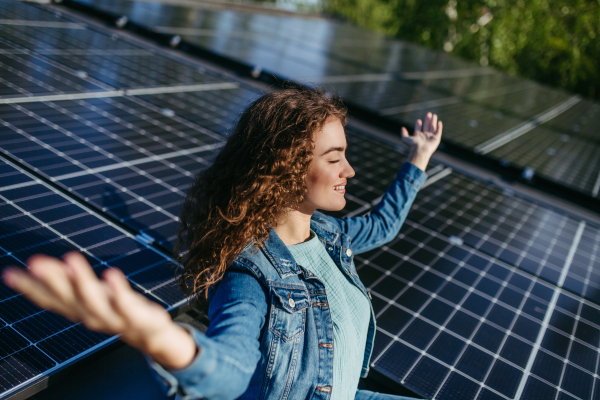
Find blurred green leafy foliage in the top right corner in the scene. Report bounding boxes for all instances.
[325,0,600,99]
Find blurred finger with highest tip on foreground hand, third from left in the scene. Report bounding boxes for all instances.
[63,252,119,331]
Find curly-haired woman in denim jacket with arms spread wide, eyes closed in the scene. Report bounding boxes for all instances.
[3,89,442,400]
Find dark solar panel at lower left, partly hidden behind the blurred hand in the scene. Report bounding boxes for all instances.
[0,154,185,398]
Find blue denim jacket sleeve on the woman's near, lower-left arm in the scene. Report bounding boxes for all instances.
[146,270,267,400]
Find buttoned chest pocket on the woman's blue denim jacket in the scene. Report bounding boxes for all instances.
[269,287,310,342]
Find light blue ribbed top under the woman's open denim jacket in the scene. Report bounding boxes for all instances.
[288,231,371,400]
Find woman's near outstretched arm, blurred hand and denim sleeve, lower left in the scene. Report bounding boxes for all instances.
[3,253,267,400]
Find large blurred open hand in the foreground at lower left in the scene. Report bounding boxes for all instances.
[3,252,196,369]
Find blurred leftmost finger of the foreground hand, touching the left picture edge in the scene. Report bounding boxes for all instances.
[2,268,80,322]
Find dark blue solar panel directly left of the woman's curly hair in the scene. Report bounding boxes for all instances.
[0,98,223,248]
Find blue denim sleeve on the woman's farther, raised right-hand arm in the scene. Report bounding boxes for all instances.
[339,162,427,254]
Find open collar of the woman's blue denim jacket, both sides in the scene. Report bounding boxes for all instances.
[262,213,340,278]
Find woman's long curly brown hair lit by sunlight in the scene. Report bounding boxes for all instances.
[175,88,347,310]
